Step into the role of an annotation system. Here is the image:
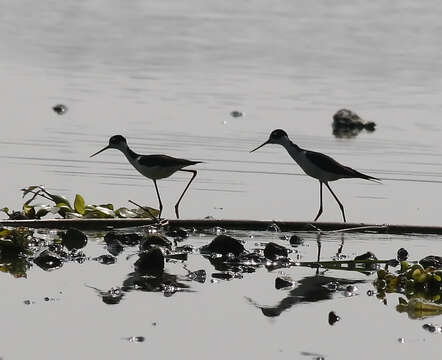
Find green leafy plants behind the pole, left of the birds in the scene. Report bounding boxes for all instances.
[1,185,159,220]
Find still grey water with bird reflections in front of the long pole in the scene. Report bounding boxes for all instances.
[0,231,442,359]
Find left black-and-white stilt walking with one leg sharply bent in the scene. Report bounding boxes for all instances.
[90,135,201,219]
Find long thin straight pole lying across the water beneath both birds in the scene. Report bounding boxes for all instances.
[0,219,442,234]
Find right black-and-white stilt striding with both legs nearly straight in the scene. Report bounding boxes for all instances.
[251,129,380,222]
